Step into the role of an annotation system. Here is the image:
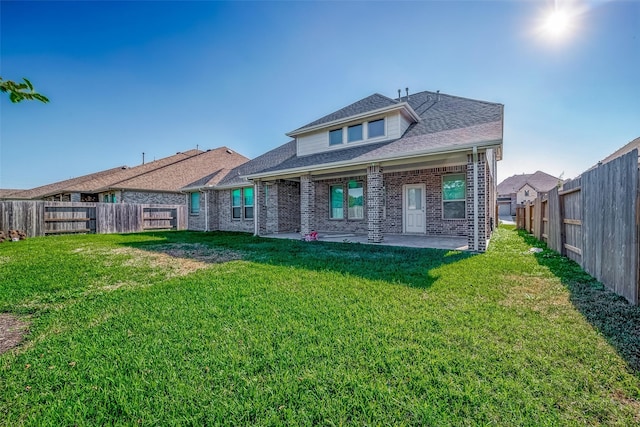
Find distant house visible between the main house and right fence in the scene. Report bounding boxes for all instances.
[498,171,562,216]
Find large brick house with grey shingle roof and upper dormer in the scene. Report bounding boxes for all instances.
[192,92,503,251]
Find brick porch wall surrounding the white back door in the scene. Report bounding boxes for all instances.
[382,166,469,236]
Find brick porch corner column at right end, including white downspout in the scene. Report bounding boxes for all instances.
[467,153,488,252]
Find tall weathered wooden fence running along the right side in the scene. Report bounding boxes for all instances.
[517,150,640,304]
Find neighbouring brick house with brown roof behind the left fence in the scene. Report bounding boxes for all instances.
[8,147,249,217]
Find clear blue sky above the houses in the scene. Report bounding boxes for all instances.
[0,0,640,188]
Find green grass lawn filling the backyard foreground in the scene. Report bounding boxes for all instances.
[0,228,640,426]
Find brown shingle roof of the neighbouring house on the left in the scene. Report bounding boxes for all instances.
[10,147,249,199]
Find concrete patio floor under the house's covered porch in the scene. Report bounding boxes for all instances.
[261,233,469,251]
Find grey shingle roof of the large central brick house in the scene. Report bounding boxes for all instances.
[243,92,503,178]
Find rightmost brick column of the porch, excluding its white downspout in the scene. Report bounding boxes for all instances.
[467,153,488,252]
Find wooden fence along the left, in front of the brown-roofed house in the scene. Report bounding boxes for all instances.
[0,201,187,237]
